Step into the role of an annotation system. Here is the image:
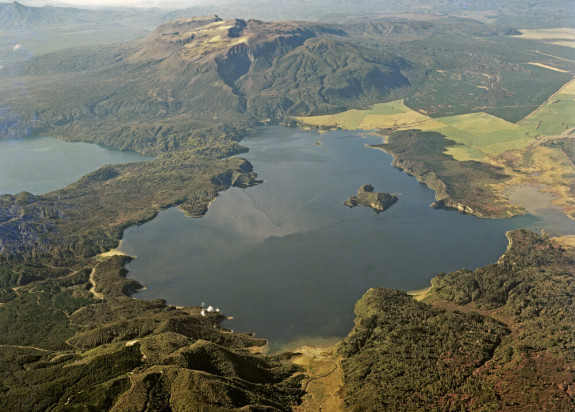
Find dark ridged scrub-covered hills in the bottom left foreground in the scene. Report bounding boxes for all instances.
[0,256,302,411]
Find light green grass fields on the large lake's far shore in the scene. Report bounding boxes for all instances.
[296,81,575,161]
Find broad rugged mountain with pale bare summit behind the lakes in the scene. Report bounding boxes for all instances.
[0,16,416,153]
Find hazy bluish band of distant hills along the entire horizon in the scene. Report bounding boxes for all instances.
[0,0,574,30]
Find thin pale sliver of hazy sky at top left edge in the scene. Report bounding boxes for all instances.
[18,0,220,8]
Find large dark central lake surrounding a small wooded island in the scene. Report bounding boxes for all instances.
[121,127,572,348]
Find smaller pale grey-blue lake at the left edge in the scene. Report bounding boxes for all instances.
[0,137,150,195]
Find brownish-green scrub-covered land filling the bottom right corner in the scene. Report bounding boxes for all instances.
[337,230,575,411]
